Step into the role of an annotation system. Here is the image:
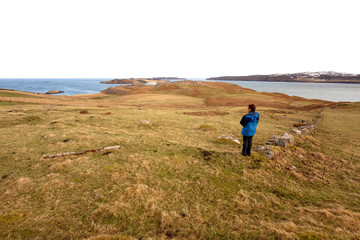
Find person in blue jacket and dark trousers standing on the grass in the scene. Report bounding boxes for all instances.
[240,104,260,156]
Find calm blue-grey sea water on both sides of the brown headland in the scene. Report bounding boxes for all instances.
[0,78,360,102]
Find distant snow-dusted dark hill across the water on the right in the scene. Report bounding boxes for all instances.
[207,71,360,83]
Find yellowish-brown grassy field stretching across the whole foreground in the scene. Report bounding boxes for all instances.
[0,86,360,240]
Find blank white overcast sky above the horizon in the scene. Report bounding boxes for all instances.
[0,0,360,78]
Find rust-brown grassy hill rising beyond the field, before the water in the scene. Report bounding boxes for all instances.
[101,80,334,110]
